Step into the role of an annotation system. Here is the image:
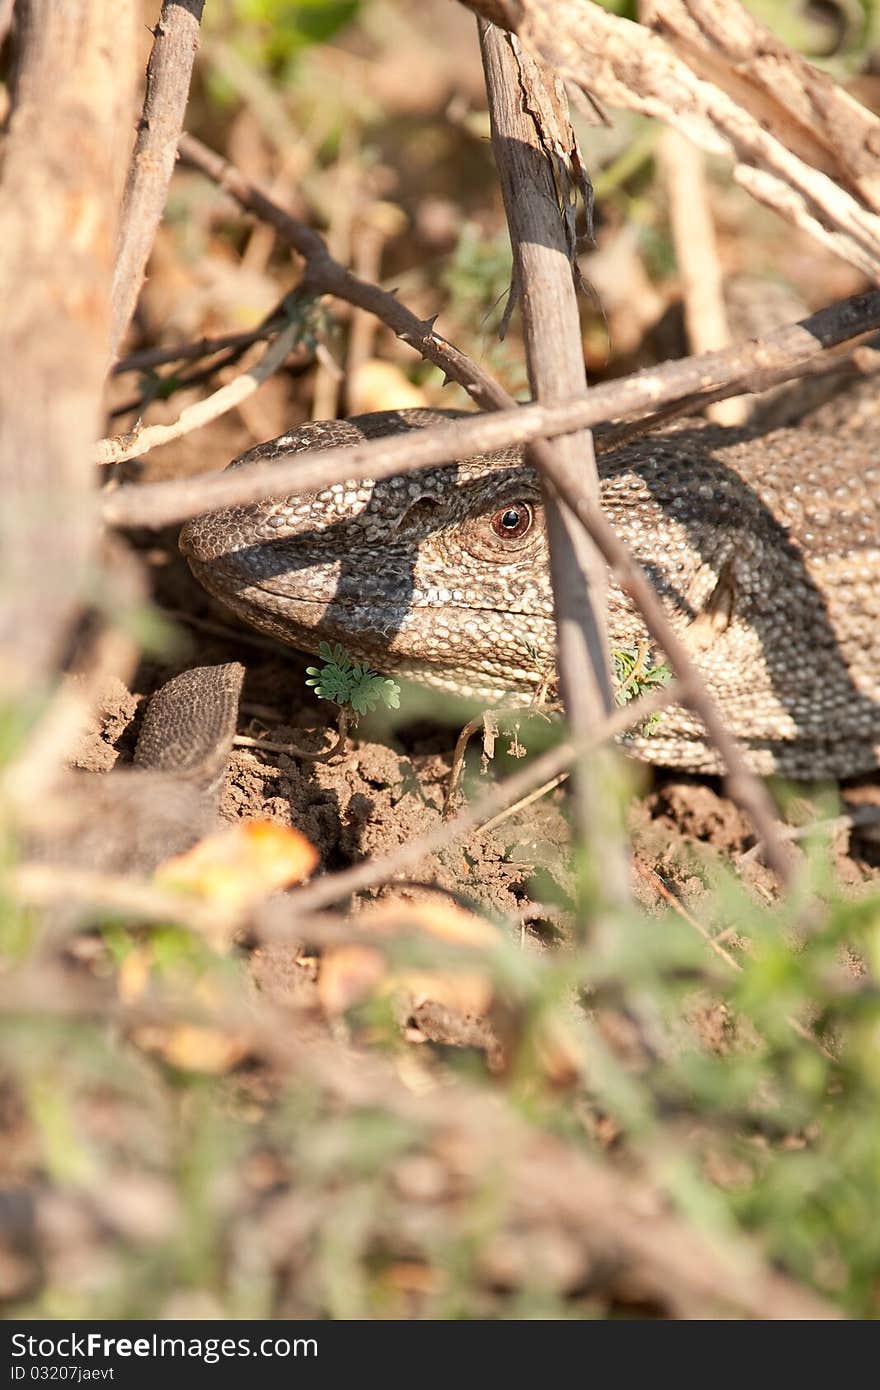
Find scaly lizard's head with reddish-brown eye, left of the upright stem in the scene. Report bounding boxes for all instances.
[181,411,553,701]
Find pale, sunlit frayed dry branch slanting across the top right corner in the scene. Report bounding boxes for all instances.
[462,0,880,281]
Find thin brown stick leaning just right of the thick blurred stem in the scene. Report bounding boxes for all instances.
[110,0,204,356]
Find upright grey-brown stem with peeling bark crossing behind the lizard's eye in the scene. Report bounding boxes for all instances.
[478,21,630,906]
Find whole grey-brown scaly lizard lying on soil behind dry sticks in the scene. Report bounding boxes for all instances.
[179,409,880,780]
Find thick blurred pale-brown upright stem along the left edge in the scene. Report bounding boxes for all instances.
[0,0,135,699]
